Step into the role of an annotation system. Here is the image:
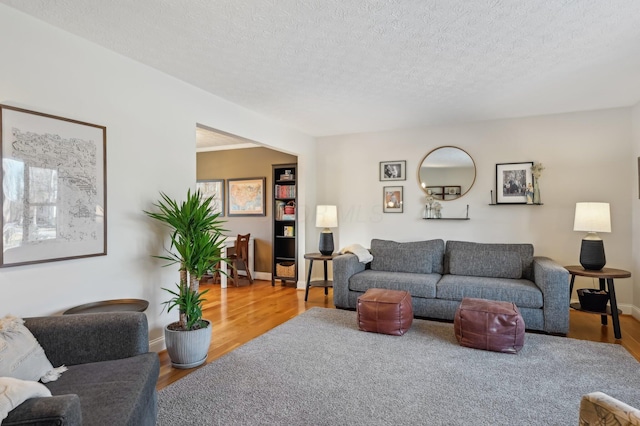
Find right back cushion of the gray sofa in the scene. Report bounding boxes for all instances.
[449,250,522,279]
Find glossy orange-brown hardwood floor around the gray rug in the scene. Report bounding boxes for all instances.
[157,280,640,389]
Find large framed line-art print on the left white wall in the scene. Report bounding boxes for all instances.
[0,105,107,267]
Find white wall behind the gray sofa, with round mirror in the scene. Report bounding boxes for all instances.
[318,108,640,312]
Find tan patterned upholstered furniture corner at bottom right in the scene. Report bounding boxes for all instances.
[580,392,640,426]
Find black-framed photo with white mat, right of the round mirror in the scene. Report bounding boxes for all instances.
[496,161,533,204]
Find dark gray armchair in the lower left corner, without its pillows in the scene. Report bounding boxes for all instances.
[2,312,160,426]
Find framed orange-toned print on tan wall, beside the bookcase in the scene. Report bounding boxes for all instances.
[227,177,266,216]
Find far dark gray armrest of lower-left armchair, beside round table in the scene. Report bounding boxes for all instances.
[24,312,149,367]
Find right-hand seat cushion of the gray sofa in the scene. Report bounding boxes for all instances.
[436,275,543,309]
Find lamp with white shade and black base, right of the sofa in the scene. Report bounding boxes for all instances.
[573,203,611,271]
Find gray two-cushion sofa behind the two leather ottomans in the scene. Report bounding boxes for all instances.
[333,239,569,334]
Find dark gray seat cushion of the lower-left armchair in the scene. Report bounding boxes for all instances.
[46,352,160,425]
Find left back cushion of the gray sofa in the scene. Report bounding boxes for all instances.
[371,247,432,274]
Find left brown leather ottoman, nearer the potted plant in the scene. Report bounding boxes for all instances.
[357,288,413,336]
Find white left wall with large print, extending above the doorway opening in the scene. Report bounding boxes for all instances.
[0,5,315,348]
